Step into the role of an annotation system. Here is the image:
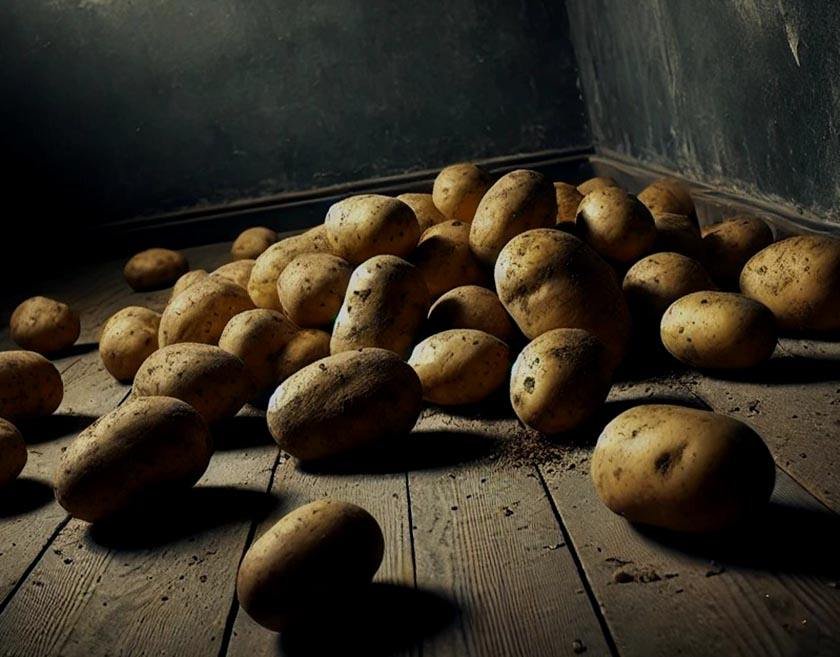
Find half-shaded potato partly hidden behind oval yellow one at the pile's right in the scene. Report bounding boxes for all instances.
[622,252,717,328]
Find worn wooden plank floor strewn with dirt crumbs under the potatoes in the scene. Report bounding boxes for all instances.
[0,244,840,657]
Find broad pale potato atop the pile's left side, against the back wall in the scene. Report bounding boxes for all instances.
[324,194,420,265]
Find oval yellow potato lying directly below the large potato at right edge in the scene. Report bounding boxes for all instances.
[660,291,777,369]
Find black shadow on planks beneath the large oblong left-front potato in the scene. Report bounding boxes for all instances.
[88,486,277,551]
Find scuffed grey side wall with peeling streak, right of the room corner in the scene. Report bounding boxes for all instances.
[567,0,840,222]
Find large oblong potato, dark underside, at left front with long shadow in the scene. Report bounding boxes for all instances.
[54,397,213,522]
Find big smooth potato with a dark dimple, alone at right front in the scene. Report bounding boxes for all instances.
[591,404,775,532]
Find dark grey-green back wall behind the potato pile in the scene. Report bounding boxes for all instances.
[0,0,590,230]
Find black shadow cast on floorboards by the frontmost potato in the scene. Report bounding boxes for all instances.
[277,583,458,657]
